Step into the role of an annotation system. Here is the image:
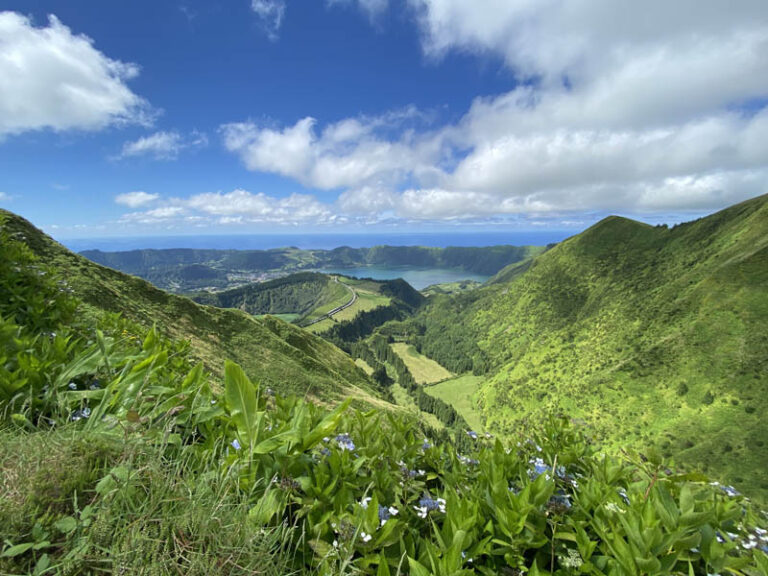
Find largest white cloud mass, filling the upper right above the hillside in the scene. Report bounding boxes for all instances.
[222,0,768,219]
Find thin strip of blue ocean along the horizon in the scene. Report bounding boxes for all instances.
[59,230,579,252]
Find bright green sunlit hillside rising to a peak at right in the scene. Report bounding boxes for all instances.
[386,196,768,498]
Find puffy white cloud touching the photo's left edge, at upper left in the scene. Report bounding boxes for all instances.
[0,12,151,138]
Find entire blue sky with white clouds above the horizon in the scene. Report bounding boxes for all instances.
[0,0,768,238]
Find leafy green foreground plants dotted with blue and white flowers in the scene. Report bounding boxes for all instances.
[0,206,765,576]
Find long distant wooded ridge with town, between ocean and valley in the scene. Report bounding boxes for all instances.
[81,246,543,292]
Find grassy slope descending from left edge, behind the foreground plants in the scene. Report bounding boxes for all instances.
[0,211,380,403]
